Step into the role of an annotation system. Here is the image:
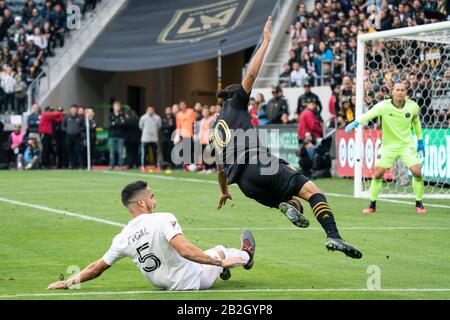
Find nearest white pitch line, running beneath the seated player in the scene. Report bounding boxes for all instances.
[0,288,450,299]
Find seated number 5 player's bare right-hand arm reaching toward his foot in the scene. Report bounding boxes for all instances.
[170,233,247,268]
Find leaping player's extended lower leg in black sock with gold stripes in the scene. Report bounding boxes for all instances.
[298,181,362,259]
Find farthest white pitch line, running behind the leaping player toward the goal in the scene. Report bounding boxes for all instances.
[97,171,450,209]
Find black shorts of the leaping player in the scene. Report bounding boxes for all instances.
[236,159,309,208]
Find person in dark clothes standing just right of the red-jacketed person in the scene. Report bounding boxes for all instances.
[62,105,84,169]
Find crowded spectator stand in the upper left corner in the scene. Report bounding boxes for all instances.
[0,0,99,114]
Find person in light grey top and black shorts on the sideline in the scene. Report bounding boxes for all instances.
[139,106,161,171]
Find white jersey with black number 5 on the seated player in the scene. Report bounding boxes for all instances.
[103,213,202,290]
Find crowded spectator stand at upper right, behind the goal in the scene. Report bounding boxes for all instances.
[278,0,450,128]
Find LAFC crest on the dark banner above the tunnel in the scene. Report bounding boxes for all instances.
[158,0,254,44]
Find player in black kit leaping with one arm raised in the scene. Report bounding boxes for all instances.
[210,17,362,259]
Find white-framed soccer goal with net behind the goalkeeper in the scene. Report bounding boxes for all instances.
[354,22,450,199]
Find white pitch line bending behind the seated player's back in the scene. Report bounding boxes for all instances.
[0,197,450,231]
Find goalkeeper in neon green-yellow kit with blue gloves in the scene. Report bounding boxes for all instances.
[345,83,425,214]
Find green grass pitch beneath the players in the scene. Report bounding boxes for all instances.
[0,171,450,299]
